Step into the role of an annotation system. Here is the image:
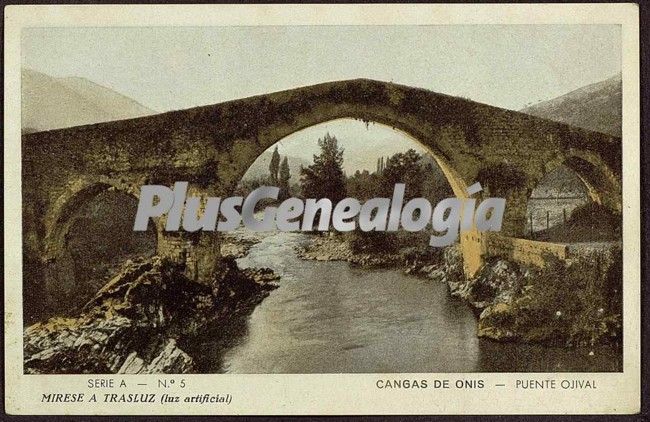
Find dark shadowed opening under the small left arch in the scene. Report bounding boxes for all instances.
[42,182,159,315]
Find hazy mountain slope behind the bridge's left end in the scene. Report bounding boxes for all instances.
[21,69,156,132]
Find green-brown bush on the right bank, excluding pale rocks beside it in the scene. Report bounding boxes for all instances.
[512,249,622,345]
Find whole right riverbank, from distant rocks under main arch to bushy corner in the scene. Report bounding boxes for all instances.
[298,236,622,346]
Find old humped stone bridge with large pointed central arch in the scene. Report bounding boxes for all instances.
[22,79,621,314]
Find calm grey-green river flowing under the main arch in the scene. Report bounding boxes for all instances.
[197,233,621,373]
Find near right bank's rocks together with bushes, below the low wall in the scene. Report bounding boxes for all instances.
[466,248,623,347]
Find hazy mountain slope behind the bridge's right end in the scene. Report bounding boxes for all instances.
[520,73,622,136]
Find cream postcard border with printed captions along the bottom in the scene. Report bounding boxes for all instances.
[4,3,641,414]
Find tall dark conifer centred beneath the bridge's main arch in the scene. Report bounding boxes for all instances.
[300,133,346,204]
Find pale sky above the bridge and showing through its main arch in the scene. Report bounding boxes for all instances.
[21,25,621,171]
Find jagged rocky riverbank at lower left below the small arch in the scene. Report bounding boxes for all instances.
[23,257,278,374]
